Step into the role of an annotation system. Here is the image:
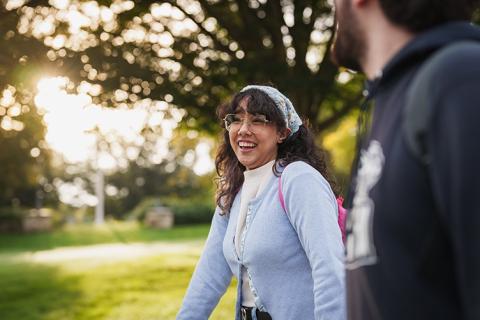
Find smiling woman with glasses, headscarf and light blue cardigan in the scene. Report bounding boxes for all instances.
[177,86,345,320]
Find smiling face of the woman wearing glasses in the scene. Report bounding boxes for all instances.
[228,97,286,170]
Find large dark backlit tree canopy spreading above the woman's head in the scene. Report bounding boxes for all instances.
[2,0,360,136]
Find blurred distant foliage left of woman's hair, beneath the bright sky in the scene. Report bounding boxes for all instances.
[106,130,215,218]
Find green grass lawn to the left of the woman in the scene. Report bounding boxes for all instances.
[0,224,235,320]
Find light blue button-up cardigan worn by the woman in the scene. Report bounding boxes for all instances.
[177,161,346,320]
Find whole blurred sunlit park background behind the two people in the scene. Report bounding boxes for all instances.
[0,0,479,320]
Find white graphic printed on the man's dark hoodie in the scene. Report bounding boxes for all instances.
[347,140,385,269]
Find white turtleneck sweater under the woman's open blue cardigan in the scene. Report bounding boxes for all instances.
[235,160,275,307]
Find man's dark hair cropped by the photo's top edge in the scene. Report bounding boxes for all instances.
[380,0,480,33]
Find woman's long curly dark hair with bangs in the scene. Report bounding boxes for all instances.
[215,89,338,214]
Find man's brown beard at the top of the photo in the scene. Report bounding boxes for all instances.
[331,1,365,71]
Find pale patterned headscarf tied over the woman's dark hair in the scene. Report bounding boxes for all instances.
[240,85,302,136]
